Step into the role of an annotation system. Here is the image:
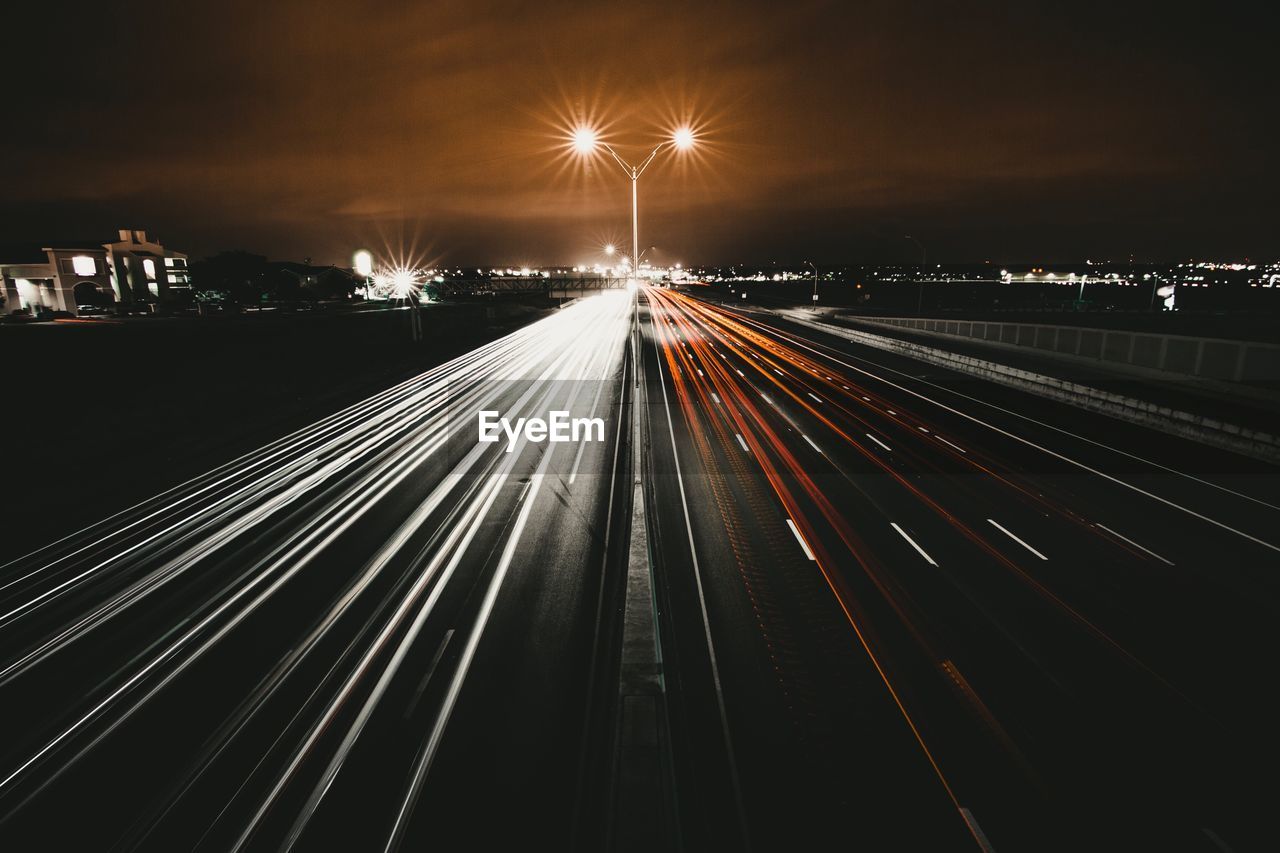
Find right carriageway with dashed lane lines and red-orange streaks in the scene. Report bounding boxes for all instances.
[645,291,1280,850]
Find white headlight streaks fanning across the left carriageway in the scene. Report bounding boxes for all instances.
[0,286,631,843]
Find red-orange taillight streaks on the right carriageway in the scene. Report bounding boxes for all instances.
[649,284,1239,838]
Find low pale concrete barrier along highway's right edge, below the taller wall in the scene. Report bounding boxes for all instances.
[778,311,1280,462]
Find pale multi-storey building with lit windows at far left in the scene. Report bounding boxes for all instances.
[0,231,191,315]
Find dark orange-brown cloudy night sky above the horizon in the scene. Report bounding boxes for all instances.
[0,0,1280,265]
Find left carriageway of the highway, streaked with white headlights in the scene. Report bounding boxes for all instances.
[0,293,631,850]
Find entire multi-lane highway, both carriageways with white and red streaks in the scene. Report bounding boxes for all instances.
[0,281,1280,853]
